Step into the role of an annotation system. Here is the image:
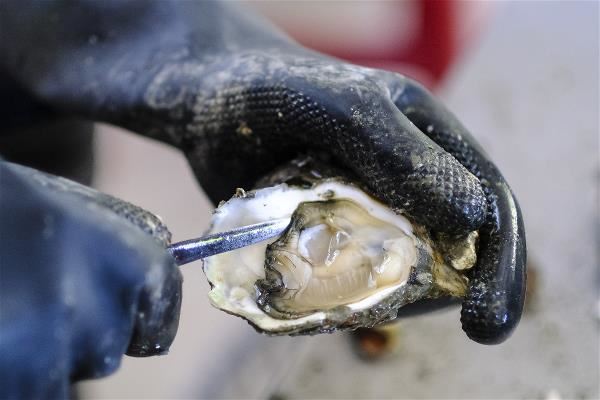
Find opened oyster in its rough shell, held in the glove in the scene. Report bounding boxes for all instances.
[204,178,477,334]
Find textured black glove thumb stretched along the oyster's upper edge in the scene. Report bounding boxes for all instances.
[183,78,485,233]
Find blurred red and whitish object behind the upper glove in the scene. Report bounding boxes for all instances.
[249,0,491,88]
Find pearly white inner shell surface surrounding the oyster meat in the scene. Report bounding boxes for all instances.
[204,181,414,332]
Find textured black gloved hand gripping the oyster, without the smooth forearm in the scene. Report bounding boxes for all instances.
[144,50,525,344]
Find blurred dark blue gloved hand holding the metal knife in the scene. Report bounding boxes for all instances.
[0,161,182,399]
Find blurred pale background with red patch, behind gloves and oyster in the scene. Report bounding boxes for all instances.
[69,1,600,399]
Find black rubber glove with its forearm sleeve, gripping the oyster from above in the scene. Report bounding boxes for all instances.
[0,1,525,343]
